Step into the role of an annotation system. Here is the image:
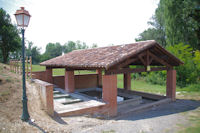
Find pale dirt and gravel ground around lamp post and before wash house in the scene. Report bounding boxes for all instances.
[0,64,200,133]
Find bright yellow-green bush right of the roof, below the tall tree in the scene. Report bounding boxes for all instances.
[167,43,200,87]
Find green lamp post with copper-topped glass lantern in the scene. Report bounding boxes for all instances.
[14,7,31,121]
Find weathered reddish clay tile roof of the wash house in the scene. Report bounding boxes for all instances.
[40,40,184,69]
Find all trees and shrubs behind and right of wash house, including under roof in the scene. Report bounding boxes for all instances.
[136,0,200,87]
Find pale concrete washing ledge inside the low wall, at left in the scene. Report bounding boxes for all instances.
[54,87,106,116]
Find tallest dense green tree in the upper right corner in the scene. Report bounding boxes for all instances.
[161,0,200,49]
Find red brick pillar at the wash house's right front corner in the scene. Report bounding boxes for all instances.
[166,69,176,101]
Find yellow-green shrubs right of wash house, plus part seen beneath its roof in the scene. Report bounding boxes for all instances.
[146,43,200,87]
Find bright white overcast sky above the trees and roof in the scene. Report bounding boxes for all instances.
[0,0,159,52]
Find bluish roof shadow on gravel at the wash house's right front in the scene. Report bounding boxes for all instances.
[115,99,200,121]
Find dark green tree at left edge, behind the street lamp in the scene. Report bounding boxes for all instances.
[0,8,21,63]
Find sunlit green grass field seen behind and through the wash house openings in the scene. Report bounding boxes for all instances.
[30,65,166,94]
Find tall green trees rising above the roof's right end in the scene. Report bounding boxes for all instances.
[136,0,200,50]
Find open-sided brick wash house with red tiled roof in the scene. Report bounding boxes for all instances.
[33,40,183,116]
